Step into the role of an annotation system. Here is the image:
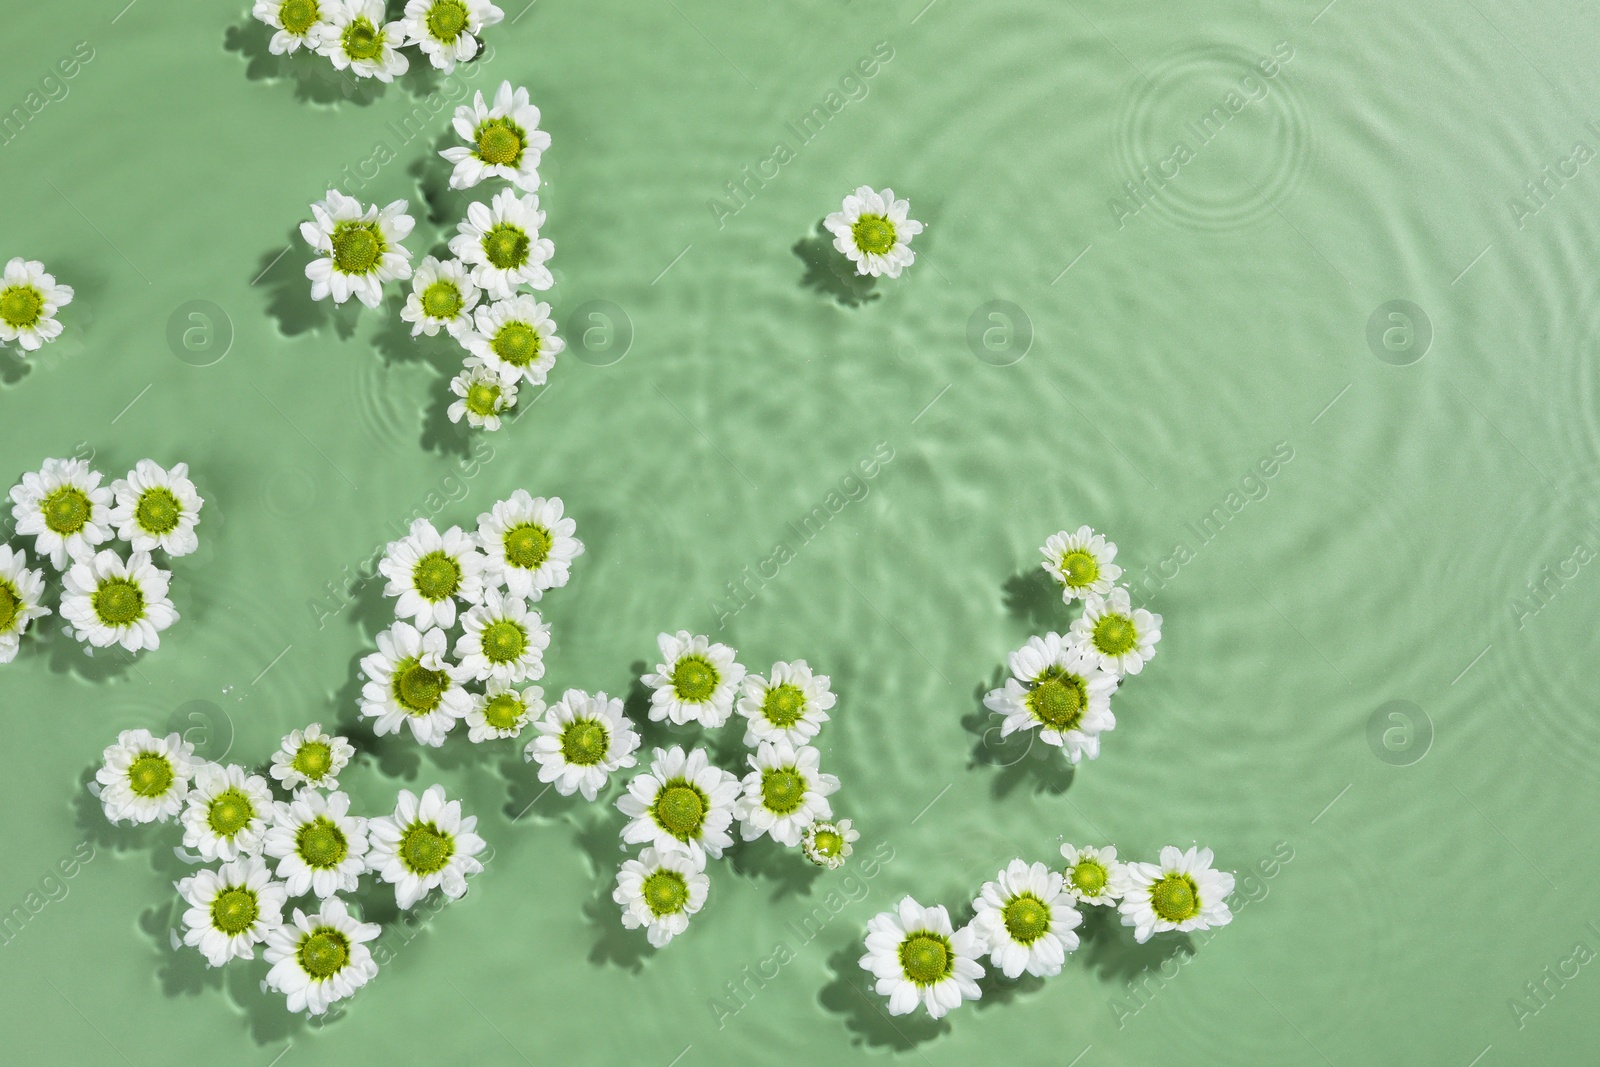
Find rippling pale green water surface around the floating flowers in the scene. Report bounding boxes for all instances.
[0,0,1600,1067]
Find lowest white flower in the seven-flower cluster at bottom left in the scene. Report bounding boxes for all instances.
[264,897,382,1016]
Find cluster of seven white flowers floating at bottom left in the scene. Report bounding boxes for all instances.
[90,723,486,1016]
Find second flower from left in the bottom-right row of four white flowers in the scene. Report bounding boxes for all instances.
[973,859,1083,979]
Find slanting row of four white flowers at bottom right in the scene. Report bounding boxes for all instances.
[861,845,1234,1019]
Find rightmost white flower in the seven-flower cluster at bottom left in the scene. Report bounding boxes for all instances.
[366,785,488,910]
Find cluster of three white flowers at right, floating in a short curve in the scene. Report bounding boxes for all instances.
[984,526,1162,763]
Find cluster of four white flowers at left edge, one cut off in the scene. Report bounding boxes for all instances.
[0,459,205,664]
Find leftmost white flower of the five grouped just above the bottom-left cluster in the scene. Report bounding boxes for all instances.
[362,622,472,749]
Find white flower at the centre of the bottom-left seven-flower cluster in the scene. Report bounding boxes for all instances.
[261,789,368,897]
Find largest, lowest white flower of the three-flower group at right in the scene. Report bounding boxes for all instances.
[984,633,1117,763]
